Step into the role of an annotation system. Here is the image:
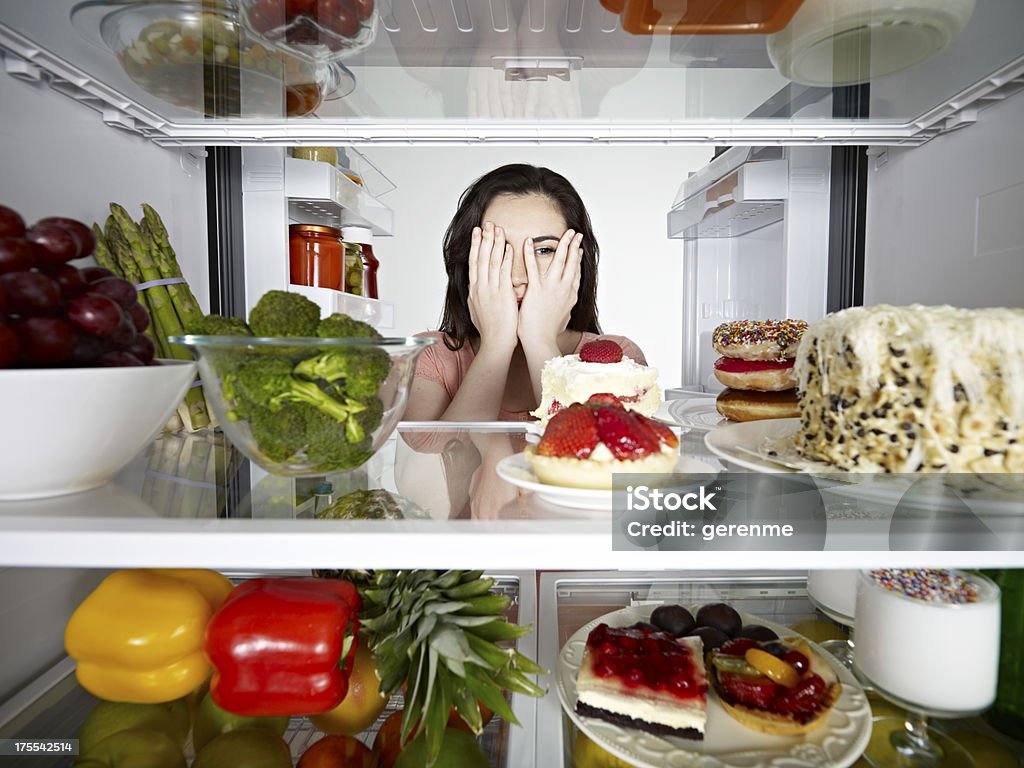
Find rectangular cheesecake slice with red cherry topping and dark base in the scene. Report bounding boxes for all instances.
[577,624,708,740]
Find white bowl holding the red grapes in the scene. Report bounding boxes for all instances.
[0,360,197,500]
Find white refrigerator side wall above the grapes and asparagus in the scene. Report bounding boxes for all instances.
[0,76,210,308]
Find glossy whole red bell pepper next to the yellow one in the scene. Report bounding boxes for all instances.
[206,579,362,717]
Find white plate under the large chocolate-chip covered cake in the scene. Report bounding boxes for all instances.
[705,419,1024,517]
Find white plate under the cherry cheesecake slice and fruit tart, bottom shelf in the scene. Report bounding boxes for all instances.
[557,605,871,768]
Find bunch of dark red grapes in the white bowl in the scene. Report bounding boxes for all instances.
[0,206,157,369]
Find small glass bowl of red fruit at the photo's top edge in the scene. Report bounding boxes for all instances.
[240,0,377,62]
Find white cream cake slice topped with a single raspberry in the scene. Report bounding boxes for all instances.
[534,338,662,424]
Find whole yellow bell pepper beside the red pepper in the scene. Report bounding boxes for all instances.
[65,568,232,703]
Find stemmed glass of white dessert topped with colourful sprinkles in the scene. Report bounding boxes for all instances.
[854,569,999,768]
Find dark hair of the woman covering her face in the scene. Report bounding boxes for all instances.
[440,163,601,349]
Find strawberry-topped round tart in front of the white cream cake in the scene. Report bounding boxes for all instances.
[525,394,679,489]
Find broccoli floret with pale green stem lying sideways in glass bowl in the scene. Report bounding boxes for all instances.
[230,357,365,423]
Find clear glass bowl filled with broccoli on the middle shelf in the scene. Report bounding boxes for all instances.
[170,335,433,475]
